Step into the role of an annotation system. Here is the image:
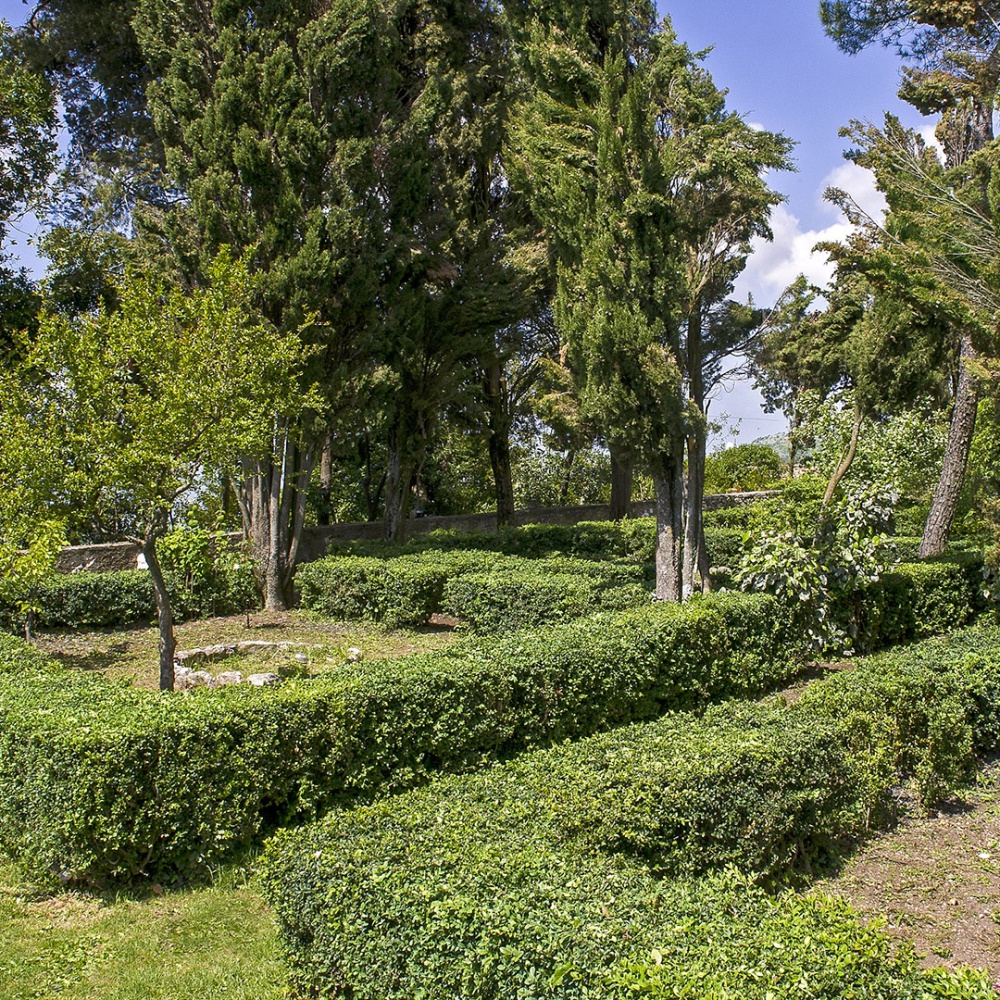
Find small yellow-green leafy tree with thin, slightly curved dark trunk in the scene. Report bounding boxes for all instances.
[0,251,303,689]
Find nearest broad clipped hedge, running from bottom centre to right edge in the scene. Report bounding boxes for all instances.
[264,629,1000,1000]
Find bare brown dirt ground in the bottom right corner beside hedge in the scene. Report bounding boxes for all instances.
[818,762,1000,981]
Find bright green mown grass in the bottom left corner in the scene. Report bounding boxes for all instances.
[0,866,285,1000]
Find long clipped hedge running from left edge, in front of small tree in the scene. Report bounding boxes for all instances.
[0,595,794,881]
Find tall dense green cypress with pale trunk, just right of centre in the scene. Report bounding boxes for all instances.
[512,4,692,600]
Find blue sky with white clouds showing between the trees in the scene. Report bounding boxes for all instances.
[0,0,932,440]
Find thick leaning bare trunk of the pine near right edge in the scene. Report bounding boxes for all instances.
[920,331,979,559]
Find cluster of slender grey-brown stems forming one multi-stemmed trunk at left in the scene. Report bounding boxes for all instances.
[239,421,316,611]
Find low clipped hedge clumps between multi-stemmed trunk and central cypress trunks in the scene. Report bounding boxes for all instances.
[296,549,652,633]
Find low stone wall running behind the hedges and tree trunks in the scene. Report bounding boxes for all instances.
[56,491,777,573]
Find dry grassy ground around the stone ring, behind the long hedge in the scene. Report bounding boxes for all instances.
[35,611,456,690]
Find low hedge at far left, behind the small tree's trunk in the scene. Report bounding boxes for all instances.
[0,570,259,630]
